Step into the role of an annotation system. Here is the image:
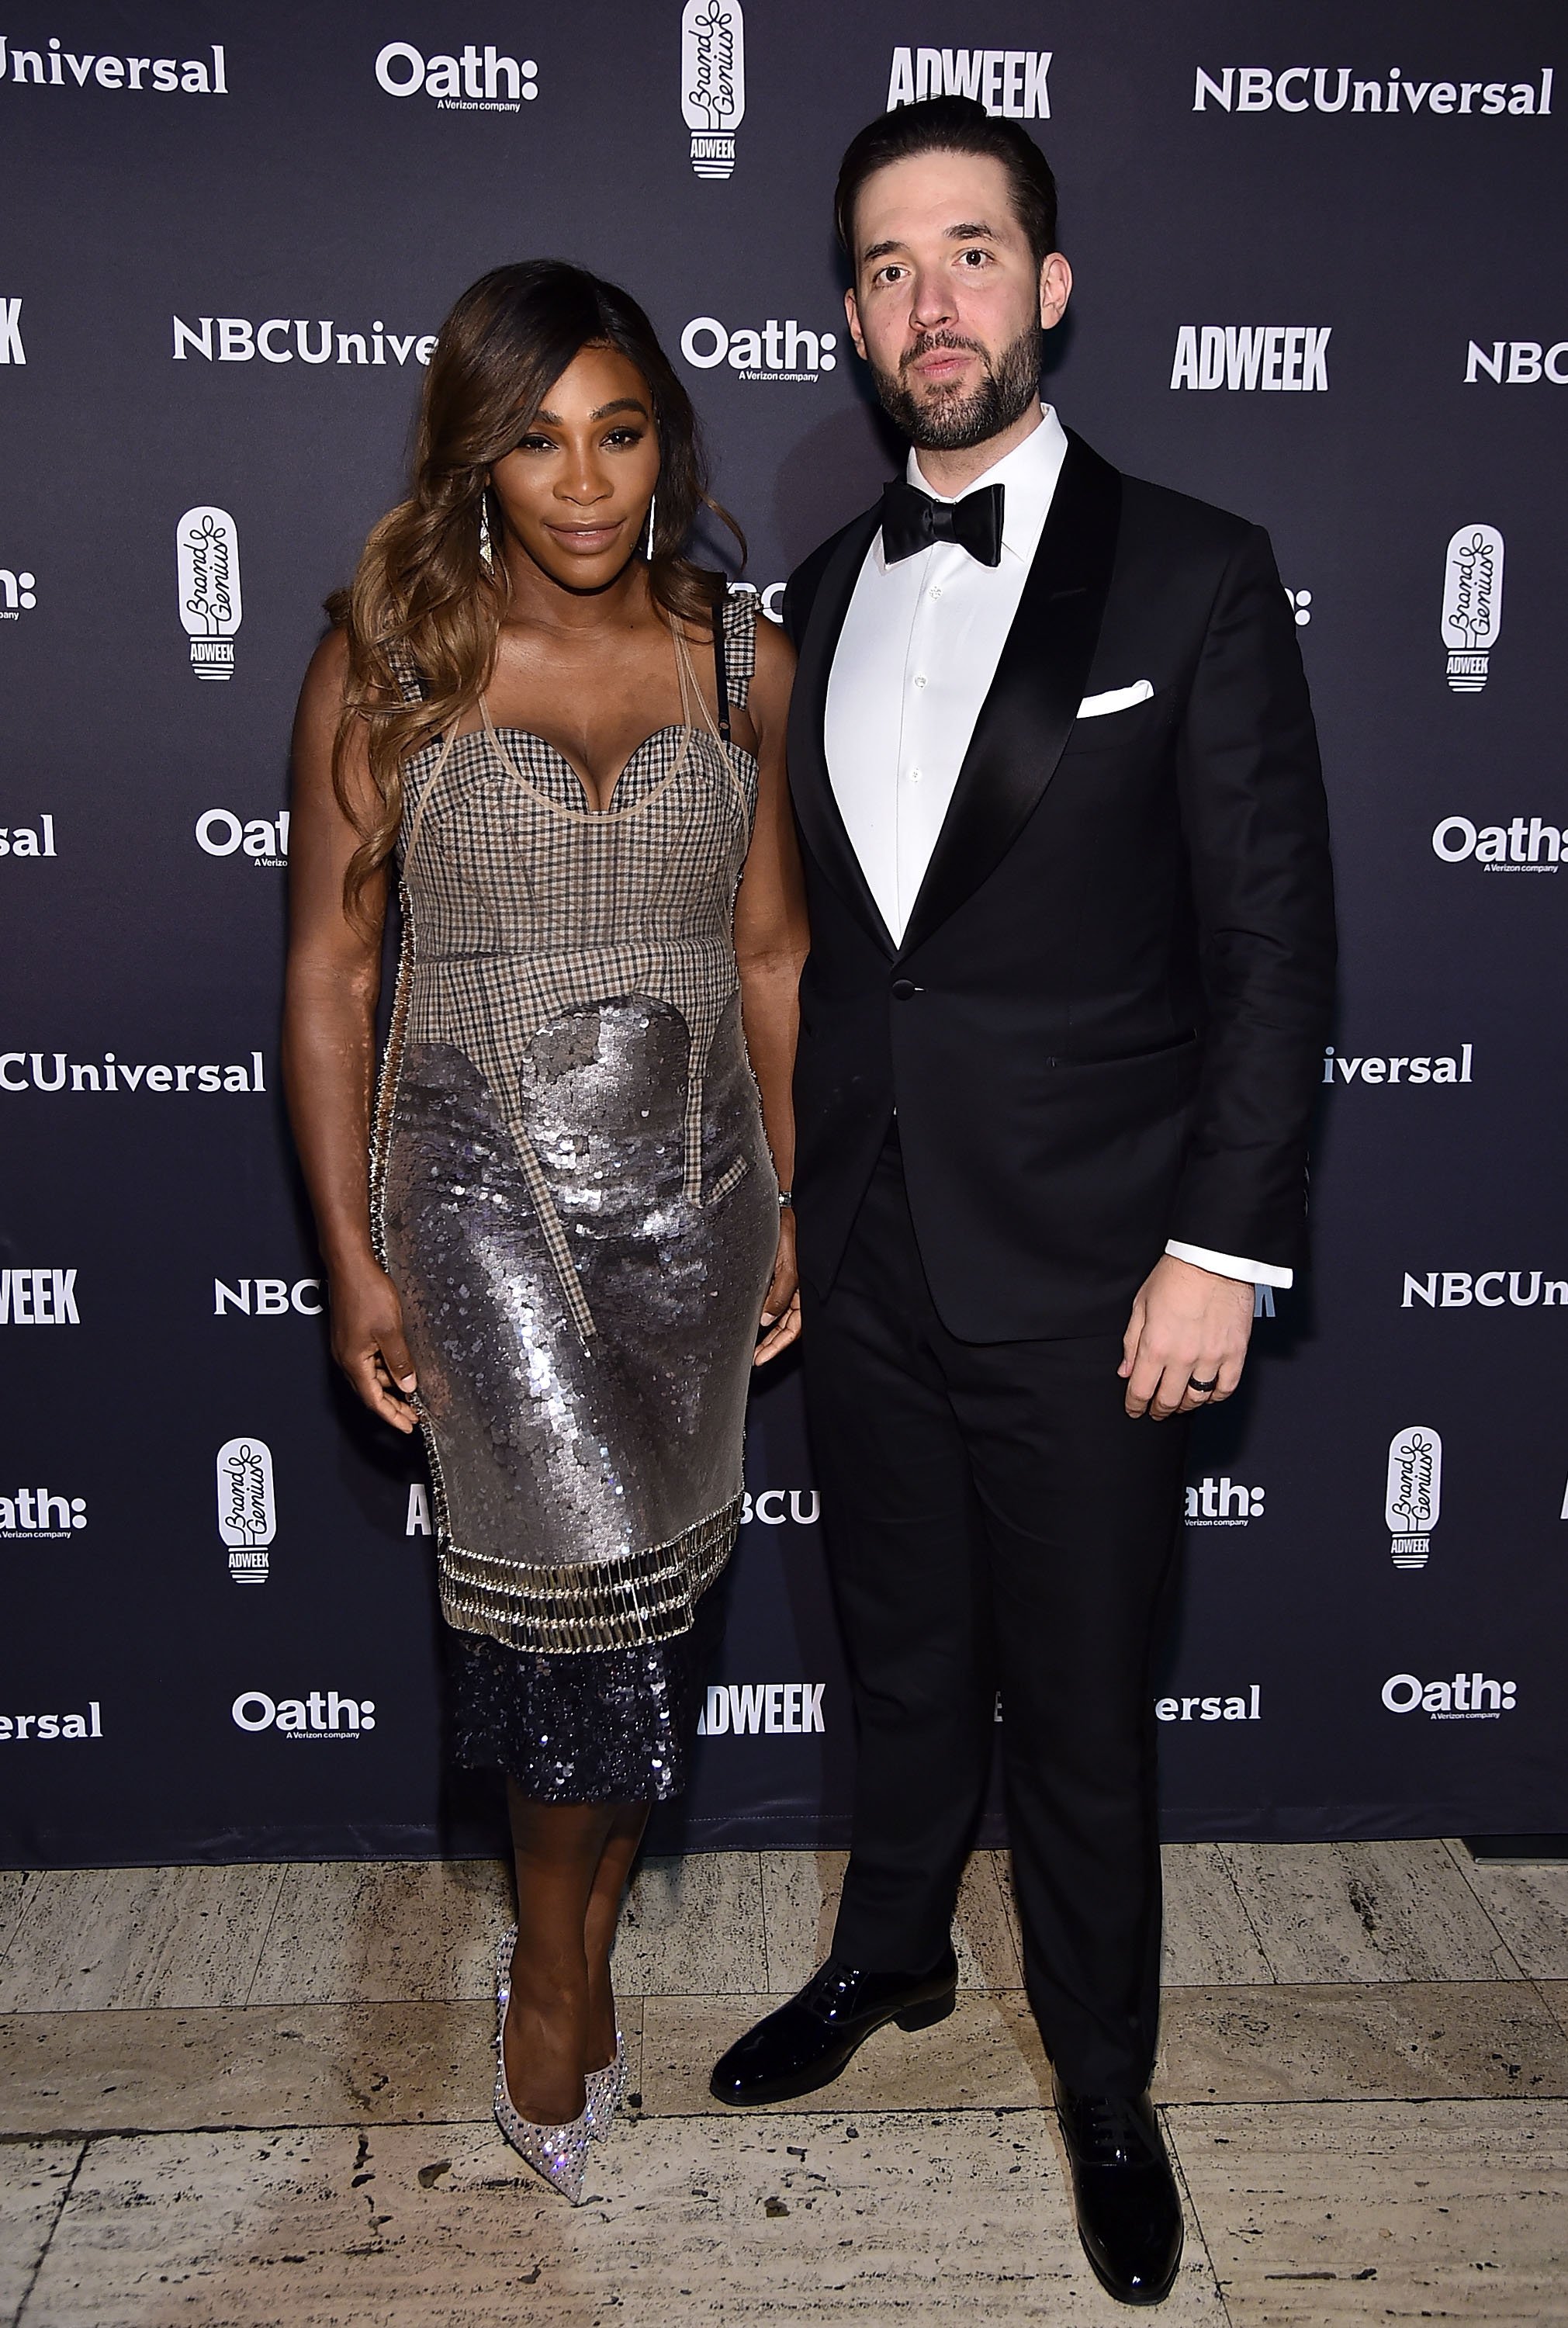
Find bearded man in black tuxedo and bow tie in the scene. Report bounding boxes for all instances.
[715,98,1333,2302]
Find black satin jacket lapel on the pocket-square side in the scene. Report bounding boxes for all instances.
[893,431,1121,954]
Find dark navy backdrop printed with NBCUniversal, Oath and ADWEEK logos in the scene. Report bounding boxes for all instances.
[0,0,1568,1862]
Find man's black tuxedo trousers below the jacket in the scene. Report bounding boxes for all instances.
[802,1138,1186,2095]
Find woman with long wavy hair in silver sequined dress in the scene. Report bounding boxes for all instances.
[284,261,805,2200]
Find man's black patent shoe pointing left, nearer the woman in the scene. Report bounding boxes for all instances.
[708,1949,958,2109]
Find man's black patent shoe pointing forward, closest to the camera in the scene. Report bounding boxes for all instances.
[1054,2079,1182,2305]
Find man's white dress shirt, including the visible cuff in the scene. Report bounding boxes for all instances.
[826,405,1291,1285]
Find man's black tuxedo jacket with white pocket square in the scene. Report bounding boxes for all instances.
[784,435,1333,1341]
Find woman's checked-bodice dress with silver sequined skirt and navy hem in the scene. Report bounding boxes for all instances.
[372,594,777,1802]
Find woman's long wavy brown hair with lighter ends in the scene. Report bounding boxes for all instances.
[326,258,745,920]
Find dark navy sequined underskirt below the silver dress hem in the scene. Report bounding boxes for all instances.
[447,1592,722,1802]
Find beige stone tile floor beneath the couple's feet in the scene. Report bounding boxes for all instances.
[0,1841,1568,2328]
